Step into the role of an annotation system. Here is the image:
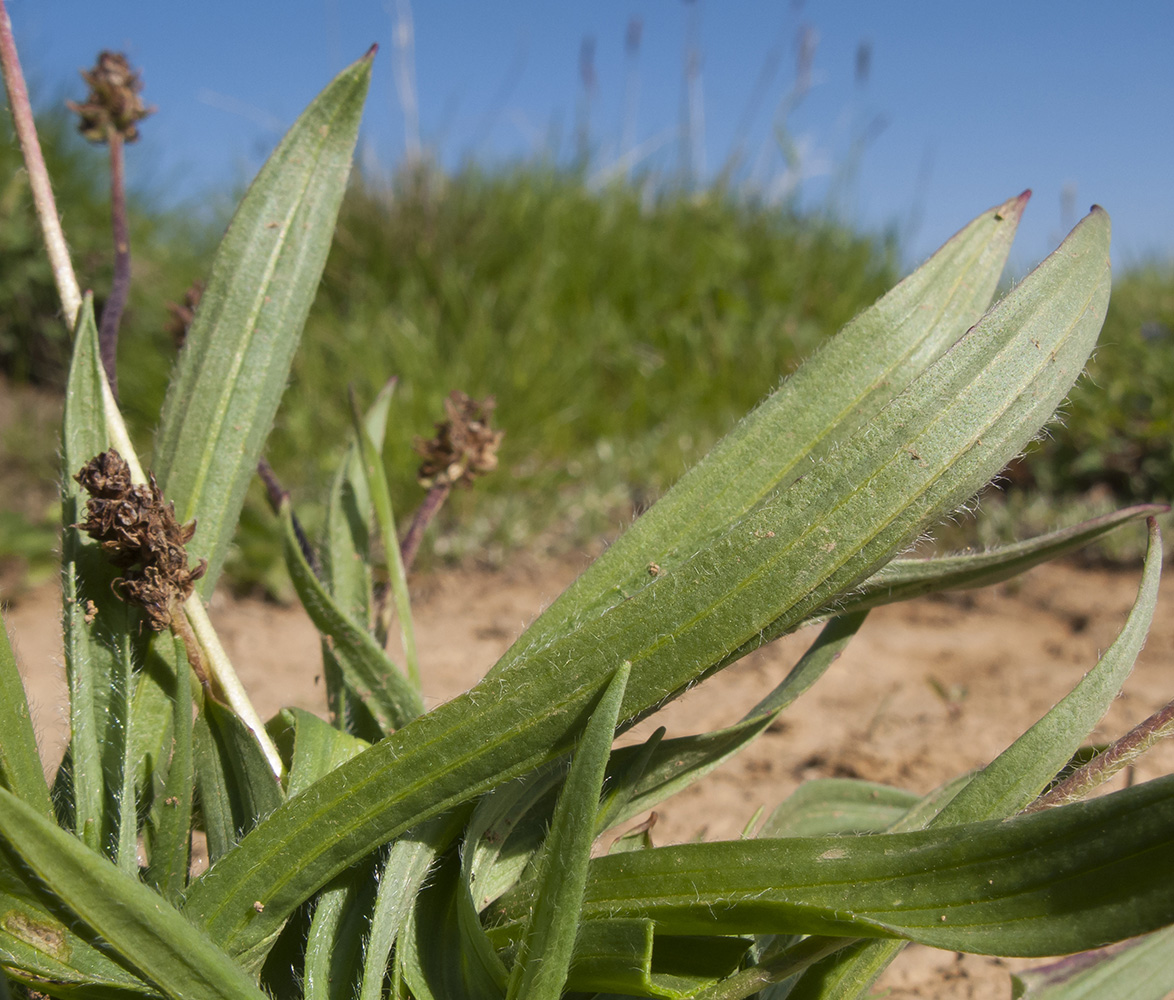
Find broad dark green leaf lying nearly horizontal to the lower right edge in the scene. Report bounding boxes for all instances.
[497,776,1174,955]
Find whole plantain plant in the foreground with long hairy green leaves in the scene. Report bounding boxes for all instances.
[0,23,1174,1000]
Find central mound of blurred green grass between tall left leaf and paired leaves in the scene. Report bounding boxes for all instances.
[261,165,897,575]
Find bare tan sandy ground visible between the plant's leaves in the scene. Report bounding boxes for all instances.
[7,551,1174,1000]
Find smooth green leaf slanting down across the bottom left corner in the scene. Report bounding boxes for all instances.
[0,789,264,1000]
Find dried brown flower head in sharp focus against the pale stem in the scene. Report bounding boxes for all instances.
[74,448,208,631]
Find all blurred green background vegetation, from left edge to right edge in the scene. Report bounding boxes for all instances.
[0,105,1174,596]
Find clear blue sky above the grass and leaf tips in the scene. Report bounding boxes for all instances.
[8,0,1174,272]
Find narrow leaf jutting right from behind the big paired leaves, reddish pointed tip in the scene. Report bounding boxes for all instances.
[836,504,1169,613]
